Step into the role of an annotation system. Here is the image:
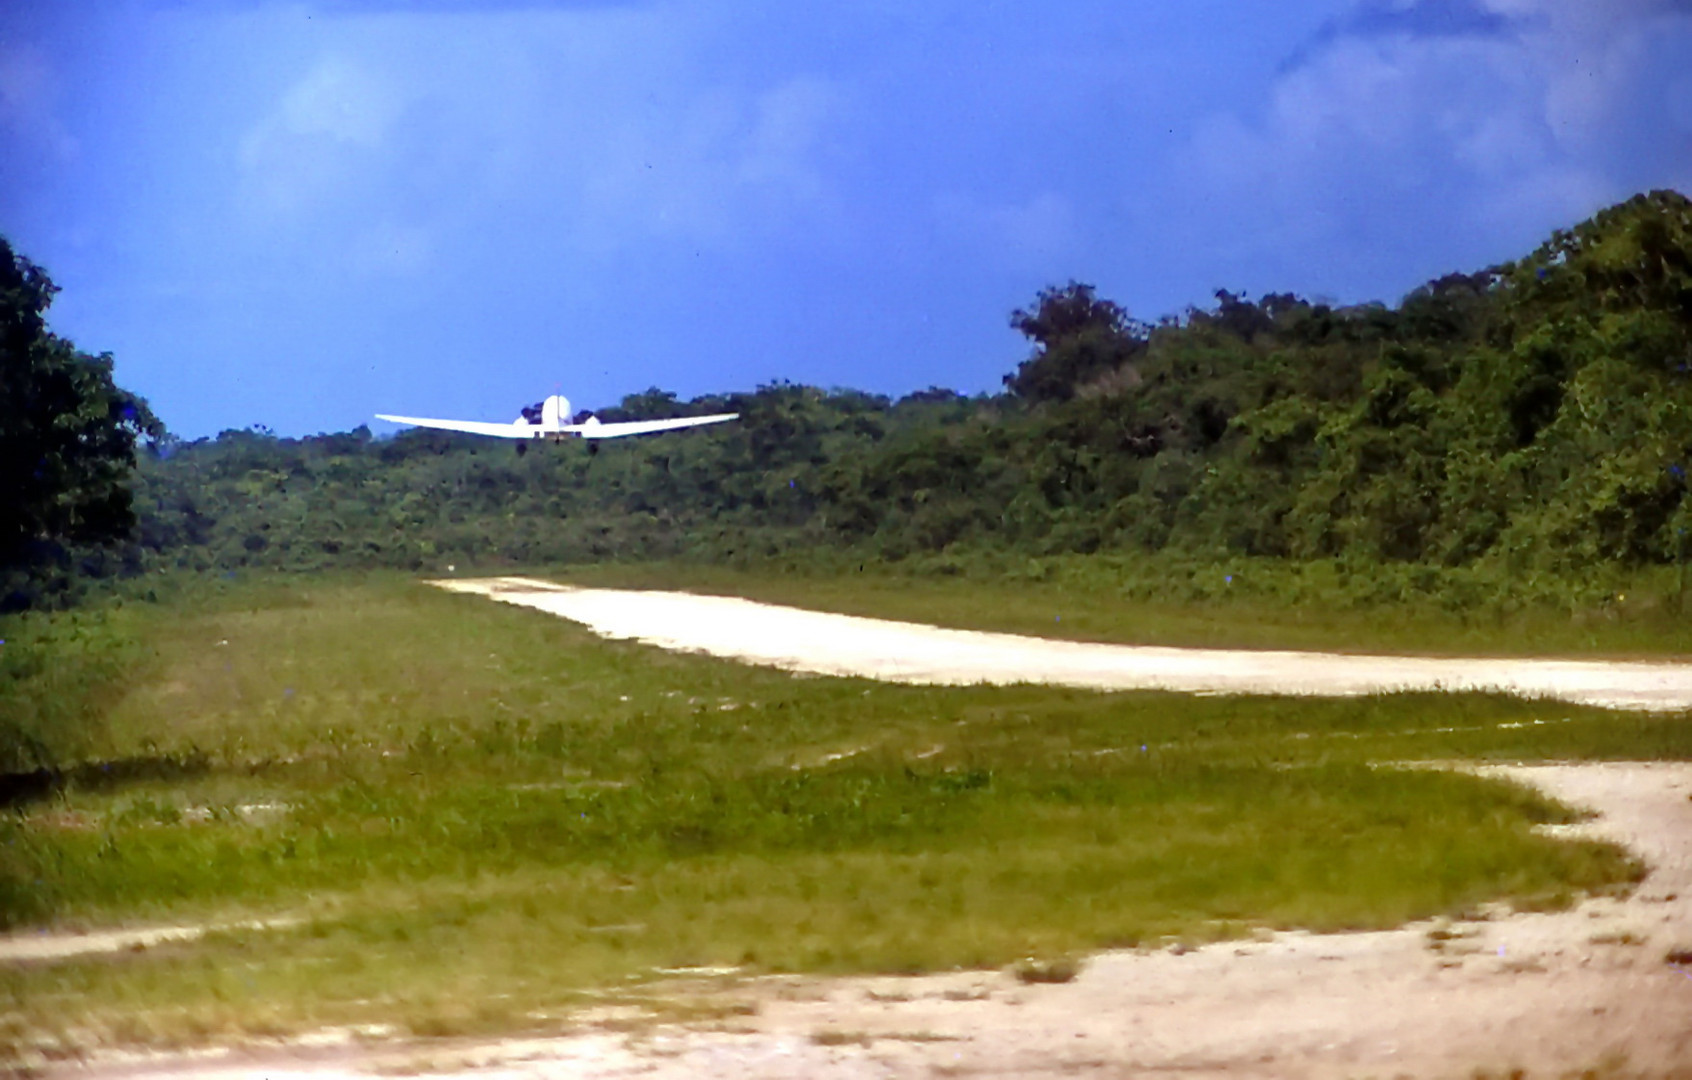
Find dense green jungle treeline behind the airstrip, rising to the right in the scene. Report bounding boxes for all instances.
[125,191,1692,592]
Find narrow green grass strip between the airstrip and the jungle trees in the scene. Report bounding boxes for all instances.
[561,555,1692,657]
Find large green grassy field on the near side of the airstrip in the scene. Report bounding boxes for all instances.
[0,577,1692,1041]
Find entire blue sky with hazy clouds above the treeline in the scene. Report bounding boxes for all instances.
[0,0,1692,437]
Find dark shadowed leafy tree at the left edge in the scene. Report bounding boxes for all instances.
[0,237,164,608]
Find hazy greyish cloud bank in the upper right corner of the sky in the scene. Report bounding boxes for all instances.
[1174,0,1692,291]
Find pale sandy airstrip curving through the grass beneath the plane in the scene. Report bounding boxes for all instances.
[433,577,1692,709]
